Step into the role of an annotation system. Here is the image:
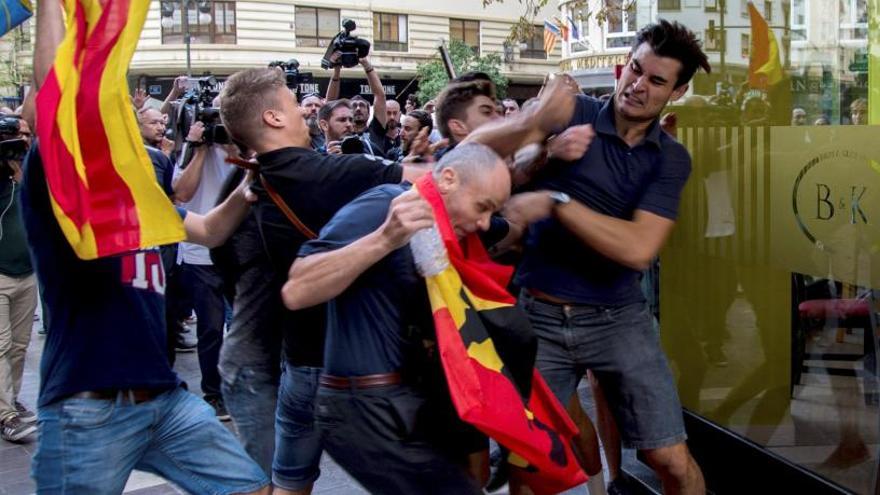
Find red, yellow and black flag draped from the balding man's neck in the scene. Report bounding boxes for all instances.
[416,174,587,495]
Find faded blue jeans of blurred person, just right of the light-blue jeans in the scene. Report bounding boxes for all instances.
[221,366,278,476]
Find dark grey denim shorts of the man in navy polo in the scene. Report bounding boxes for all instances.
[520,292,687,450]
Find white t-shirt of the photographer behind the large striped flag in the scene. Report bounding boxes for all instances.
[174,145,234,265]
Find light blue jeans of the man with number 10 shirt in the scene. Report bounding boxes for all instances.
[31,388,269,495]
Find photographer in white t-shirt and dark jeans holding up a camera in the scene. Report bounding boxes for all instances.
[173,113,237,421]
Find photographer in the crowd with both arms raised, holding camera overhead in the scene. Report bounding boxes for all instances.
[327,57,388,157]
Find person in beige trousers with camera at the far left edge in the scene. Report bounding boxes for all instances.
[0,114,37,442]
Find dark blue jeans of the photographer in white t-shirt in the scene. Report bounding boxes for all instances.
[181,263,226,398]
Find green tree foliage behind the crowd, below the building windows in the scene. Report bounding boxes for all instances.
[416,40,508,104]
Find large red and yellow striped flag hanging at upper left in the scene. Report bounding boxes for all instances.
[37,0,184,259]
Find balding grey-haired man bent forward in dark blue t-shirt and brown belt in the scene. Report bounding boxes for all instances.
[283,143,510,494]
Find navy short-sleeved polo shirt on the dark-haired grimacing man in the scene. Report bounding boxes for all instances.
[517,96,691,305]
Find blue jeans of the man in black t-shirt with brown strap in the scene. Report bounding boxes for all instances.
[272,362,323,491]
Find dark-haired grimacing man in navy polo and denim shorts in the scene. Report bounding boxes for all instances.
[506,20,710,493]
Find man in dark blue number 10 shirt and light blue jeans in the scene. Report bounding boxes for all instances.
[22,145,269,493]
